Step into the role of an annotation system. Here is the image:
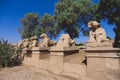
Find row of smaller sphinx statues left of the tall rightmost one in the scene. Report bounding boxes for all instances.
[17,33,76,49]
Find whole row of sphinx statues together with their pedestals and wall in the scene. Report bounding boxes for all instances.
[17,21,120,80]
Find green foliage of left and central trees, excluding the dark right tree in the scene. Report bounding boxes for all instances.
[19,0,95,39]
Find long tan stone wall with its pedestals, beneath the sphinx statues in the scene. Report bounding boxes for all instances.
[24,48,120,80]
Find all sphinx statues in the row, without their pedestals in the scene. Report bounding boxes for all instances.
[18,21,112,48]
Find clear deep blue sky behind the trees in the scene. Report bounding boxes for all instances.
[0,0,115,43]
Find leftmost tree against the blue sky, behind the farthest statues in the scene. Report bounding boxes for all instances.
[19,13,40,39]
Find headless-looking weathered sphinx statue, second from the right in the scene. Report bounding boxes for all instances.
[57,34,75,47]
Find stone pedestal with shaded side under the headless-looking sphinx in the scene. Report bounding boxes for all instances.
[49,48,78,73]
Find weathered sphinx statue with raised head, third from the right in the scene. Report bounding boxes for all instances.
[39,33,57,48]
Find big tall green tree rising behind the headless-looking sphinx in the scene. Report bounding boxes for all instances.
[55,0,94,38]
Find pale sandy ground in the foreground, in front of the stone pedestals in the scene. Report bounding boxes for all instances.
[0,65,79,80]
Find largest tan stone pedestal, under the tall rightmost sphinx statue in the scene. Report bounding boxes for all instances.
[85,48,120,80]
